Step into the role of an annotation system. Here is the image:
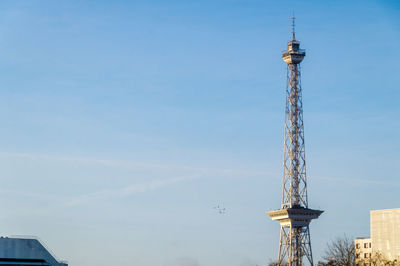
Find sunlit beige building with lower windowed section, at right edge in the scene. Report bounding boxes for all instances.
[354,209,400,264]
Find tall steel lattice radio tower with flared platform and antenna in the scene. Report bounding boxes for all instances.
[267,17,323,266]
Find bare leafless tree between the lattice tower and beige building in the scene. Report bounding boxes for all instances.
[318,236,355,266]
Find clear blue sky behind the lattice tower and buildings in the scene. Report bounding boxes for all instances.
[0,0,400,266]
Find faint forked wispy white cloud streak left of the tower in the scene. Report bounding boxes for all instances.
[0,152,279,206]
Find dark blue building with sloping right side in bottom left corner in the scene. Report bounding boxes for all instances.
[0,237,68,266]
